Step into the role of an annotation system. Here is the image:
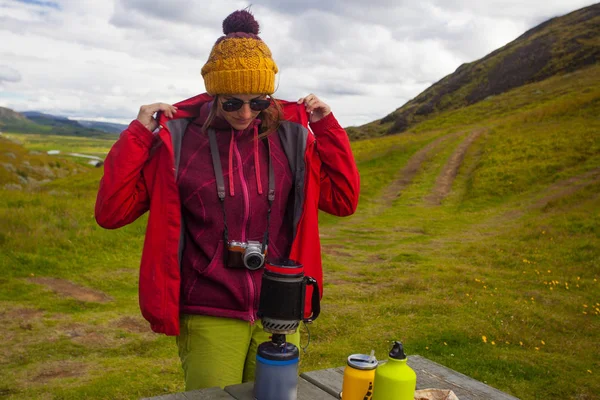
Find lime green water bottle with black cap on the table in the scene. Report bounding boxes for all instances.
[373,341,417,400]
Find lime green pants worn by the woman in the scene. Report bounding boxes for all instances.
[177,315,300,390]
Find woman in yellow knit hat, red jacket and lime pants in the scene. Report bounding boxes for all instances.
[96,10,359,390]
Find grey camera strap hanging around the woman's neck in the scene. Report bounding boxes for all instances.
[208,128,275,254]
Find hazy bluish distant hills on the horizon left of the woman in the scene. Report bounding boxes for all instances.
[0,107,120,138]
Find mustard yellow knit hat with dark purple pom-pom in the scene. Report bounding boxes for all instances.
[202,10,278,96]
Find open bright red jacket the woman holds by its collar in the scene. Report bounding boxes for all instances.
[95,94,360,335]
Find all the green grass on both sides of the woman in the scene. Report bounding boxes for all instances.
[0,67,600,400]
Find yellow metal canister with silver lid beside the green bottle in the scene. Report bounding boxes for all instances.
[340,352,377,400]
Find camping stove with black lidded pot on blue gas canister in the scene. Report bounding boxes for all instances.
[254,259,320,400]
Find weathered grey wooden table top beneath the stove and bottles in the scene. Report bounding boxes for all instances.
[143,356,519,400]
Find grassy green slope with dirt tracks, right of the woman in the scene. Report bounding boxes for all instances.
[316,66,600,399]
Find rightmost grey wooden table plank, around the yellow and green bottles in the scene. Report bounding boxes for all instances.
[301,356,518,400]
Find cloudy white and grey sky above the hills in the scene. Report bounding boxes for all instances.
[0,0,595,126]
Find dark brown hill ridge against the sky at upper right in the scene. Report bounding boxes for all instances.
[348,4,600,139]
